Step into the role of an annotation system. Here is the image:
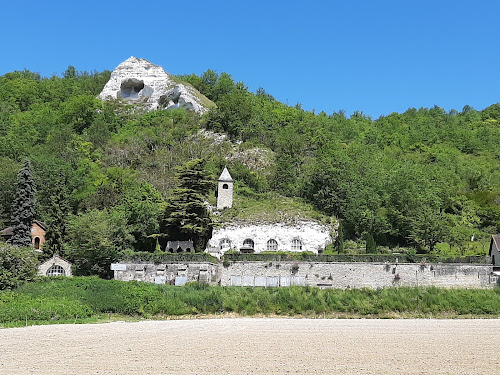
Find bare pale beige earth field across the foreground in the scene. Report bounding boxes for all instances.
[0,318,500,375]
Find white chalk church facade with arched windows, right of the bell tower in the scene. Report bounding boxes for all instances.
[207,221,332,256]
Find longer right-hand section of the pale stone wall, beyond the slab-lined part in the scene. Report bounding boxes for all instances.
[220,261,496,289]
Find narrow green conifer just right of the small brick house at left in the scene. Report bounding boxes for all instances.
[44,176,69,256]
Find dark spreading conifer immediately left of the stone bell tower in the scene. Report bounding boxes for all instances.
[160,159,213,252]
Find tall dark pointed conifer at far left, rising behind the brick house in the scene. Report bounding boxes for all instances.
[10,160,35,247]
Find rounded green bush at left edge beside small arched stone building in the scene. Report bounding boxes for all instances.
[0,244,38,290]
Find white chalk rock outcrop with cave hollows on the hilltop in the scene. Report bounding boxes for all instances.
[99,57,215,114]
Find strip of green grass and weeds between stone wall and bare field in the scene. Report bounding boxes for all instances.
[0,277,500,327]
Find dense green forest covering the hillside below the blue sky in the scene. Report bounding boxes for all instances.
[0,66,500,273]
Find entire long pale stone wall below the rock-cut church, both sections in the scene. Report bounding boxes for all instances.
[112,261,497,289]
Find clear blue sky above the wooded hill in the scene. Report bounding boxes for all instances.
[0,0,500,118]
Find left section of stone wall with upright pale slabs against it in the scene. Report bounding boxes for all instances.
[111,262,219,285]
